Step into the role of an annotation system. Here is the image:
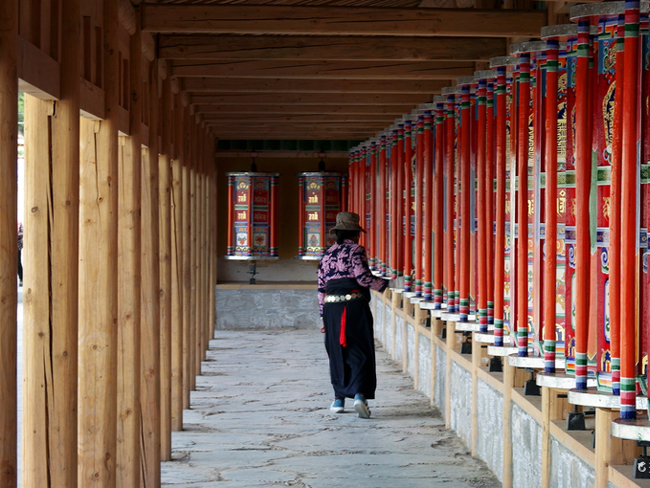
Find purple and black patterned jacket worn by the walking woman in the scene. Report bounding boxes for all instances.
[318,239,388,317]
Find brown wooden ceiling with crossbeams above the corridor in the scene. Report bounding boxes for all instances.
[141,0,566,140]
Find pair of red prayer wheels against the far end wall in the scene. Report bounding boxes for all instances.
[226,171,347,261]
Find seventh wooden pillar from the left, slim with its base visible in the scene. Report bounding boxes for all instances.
[170,94,189,420]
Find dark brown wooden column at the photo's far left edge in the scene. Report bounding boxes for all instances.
[0,0,18,488]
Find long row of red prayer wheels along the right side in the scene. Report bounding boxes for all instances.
[349,1,650,419]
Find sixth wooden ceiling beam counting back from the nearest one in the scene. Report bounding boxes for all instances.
[194,103,415,114]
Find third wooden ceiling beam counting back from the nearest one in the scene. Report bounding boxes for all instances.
[171,60,474,80]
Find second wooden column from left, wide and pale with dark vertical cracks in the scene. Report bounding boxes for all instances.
[21,0,80,488]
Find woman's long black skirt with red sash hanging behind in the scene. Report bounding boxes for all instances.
[323,278,377,399]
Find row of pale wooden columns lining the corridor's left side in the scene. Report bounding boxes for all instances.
[6,0,216,488]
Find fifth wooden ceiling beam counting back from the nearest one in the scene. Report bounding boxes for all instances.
[191,93,433,106]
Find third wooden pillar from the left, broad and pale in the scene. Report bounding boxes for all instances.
[78,2,120,480]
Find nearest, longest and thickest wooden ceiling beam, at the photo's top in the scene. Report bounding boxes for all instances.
[143,4,546,37]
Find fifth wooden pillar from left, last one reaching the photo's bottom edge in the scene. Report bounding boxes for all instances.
[140,49,161,488]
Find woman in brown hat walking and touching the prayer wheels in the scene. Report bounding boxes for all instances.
[318,212,388,418]
